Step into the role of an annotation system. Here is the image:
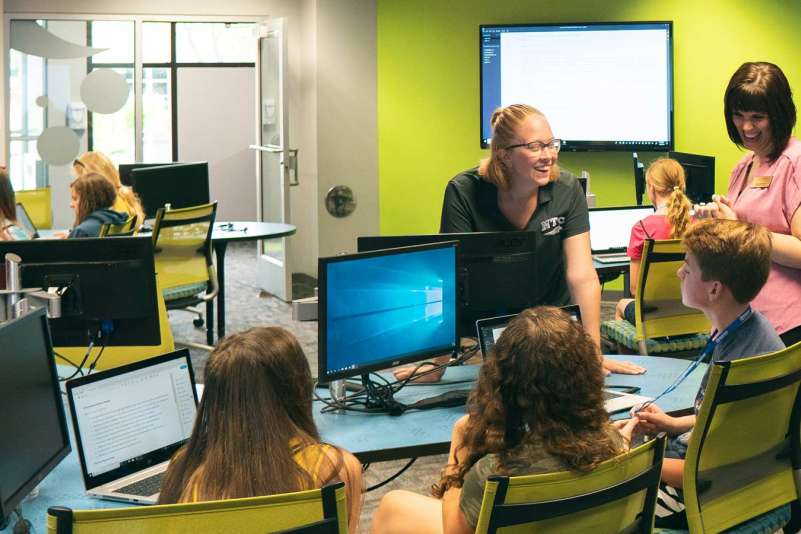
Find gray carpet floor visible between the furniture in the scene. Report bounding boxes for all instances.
[170,243,617,533]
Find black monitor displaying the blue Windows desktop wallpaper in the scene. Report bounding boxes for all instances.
[318,242,459,381]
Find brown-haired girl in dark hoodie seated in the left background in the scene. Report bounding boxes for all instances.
[67,172,128,238]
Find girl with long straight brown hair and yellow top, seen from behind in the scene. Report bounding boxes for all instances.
[159,327,362,532]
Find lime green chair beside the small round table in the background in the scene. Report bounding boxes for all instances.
[153,202,219,350]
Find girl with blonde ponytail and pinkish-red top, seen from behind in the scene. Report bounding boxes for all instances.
[615,158,692,324]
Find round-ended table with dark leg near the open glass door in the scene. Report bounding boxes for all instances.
[206,221,295,345]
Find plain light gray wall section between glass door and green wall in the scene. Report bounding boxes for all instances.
[317,0,379,256]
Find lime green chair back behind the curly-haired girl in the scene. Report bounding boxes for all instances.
[476,434,666,534]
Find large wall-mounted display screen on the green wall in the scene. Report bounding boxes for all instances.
[479,22,674,152]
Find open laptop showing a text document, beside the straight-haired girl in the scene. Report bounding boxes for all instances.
[67,349,197,504]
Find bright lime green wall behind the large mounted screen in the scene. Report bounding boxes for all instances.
[376,0,801,235]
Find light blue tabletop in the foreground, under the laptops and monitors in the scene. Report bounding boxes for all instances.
[0,356,706,533]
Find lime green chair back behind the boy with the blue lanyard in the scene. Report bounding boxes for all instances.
[684,344,801,532]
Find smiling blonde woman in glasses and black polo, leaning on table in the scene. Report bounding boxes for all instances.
[440,104,645,374]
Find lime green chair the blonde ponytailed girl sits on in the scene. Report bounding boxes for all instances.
[601,239,711,355]
